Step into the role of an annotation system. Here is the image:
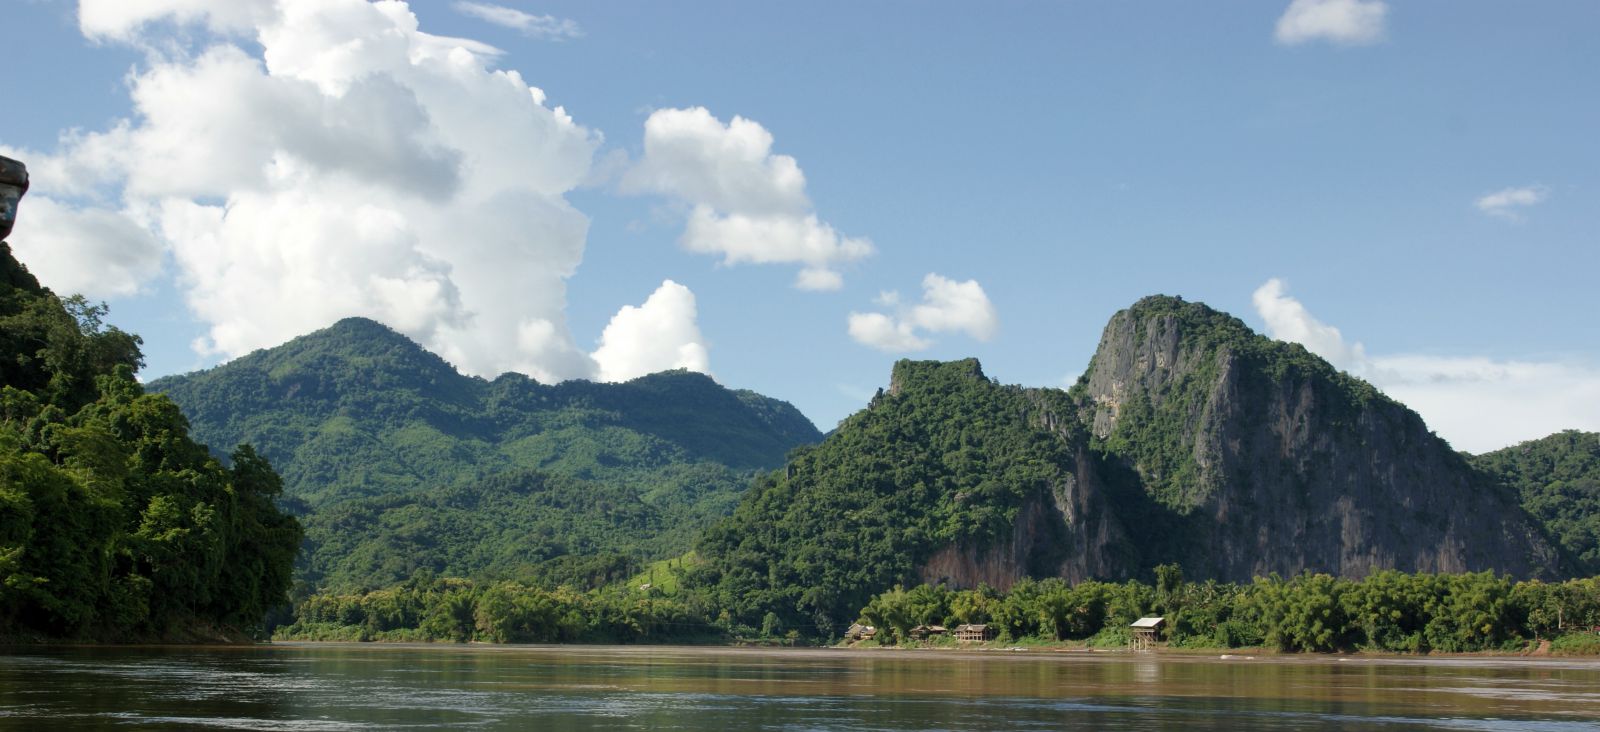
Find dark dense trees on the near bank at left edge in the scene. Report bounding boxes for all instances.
[0,243,301,641]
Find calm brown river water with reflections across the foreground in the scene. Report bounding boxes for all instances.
[0,644,1600,732]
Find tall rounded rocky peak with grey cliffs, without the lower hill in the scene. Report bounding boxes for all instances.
[1075,297,1560,580]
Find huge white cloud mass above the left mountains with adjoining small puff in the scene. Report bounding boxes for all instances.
[6,0,709,382]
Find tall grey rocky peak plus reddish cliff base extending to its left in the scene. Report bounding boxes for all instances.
[915,297,1571,588]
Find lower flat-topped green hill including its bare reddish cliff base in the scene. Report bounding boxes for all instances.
[685,360,1139,636]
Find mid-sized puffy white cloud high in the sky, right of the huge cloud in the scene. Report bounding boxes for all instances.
[621,107,872,289]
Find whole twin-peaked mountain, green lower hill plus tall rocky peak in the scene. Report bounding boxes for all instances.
[686,297,1571,635]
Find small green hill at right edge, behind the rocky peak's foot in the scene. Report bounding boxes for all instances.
[1470,430,1600,574]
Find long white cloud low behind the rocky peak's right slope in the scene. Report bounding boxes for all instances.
[1254,280,1600,452]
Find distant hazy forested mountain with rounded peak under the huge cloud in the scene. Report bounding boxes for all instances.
[149,318,821,588]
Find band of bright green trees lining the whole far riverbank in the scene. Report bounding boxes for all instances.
[275,566,1600,655]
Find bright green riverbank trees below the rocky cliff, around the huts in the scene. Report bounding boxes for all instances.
[861,564,1600,654]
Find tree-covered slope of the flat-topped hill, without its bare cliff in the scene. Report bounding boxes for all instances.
[690,360,1074,635]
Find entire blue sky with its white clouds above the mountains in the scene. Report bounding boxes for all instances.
[0,0,1600,451]
